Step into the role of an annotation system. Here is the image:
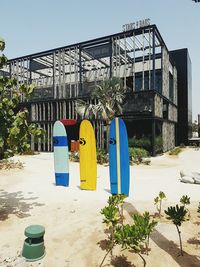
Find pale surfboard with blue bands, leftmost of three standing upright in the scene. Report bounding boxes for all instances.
[53,121,69,186]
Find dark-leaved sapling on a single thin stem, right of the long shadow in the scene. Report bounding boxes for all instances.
[165,205,187,256]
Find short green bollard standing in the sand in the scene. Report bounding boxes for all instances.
[22,225,45,261]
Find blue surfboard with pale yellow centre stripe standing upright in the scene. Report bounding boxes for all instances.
[109,118,130,196]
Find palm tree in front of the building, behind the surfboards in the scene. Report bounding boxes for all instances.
[76,77,125,149]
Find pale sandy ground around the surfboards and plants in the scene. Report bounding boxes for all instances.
[0,148,200,267]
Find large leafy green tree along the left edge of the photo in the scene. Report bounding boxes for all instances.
[0,39,45,159]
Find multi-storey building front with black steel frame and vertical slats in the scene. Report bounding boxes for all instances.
[4,25,177,155]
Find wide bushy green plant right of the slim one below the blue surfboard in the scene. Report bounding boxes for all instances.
[115,212,157,266]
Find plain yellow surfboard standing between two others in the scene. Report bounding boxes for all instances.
[79,120,97,190]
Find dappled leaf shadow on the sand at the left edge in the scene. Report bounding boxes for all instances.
[0,190,44,221]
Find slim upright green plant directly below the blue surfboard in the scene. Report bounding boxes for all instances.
[100,195,123,267]
